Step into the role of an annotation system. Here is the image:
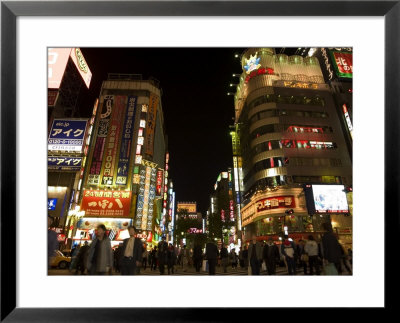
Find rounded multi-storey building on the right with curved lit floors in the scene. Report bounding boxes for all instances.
[231,48,352,247]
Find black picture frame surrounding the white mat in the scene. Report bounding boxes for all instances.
[0,0,400,322]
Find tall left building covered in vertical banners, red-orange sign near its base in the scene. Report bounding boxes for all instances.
[76,74,166,245]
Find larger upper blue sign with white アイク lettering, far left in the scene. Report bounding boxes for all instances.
[48,119,88,152]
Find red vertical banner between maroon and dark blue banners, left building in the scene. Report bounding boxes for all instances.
[102,96,126,185]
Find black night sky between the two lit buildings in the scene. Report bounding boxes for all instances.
[78,48,244,215]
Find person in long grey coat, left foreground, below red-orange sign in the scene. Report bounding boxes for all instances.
[86,224,114,275]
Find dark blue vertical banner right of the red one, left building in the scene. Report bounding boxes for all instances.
[115,96,137,185]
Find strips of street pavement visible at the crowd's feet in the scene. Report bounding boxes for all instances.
[49,266,350,276]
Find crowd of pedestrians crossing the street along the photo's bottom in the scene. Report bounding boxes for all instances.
[49,220,352,275]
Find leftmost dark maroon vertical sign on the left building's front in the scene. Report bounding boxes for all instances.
[87,95,114,185]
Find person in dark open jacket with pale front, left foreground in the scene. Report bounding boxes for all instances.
[120,225,143,276]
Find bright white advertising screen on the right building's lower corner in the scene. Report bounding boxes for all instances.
[312,185,349,213]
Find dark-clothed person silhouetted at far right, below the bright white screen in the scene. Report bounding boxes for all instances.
[322,222,342,275]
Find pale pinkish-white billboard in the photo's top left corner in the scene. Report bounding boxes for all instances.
[47,48,71,89]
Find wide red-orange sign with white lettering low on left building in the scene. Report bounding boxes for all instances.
[81,190,132,217]
